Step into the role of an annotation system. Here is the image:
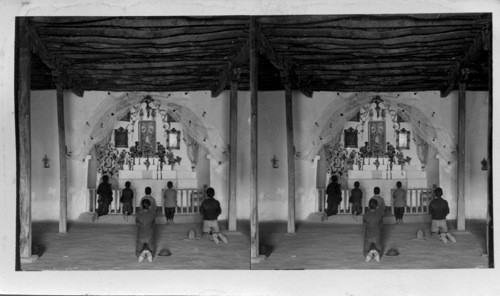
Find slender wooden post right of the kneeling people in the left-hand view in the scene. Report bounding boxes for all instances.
[228,69,241,231]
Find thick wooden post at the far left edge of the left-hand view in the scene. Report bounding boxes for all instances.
[17,42,38,262]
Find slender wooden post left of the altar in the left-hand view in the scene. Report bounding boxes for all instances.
[56,83,68,233]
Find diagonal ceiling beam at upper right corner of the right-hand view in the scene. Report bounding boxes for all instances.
[440,25,491,98]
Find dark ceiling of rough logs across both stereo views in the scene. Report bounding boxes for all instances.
[19,14,492,95]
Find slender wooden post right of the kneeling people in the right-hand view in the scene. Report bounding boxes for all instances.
[457,74,467,230]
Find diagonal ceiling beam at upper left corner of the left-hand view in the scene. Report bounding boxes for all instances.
[23,20,84,97]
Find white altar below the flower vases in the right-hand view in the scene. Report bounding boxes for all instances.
[347,157,427,206]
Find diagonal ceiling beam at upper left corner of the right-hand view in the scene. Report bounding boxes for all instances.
[256,22,313,98]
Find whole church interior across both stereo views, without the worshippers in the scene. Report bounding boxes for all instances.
[15,13,494,271]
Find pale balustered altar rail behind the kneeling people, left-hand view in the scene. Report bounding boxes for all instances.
[87,188,206,215]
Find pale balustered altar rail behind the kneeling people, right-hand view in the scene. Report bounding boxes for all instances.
[318,188,434,215]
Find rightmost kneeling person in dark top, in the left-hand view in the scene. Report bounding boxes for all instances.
[200,187,227,244]
